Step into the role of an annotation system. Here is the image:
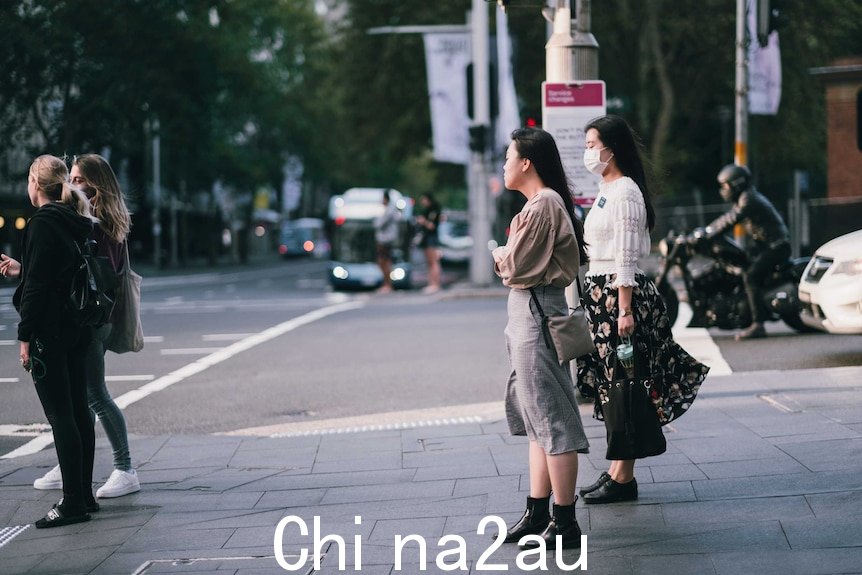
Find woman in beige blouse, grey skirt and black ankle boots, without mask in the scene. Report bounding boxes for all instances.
[493,128,589,549]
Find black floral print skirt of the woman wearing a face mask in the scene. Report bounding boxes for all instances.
[577,274,709,428]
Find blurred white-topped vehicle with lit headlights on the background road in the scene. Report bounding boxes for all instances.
[328,188,413,290]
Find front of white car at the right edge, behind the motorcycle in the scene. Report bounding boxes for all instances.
[799,230,862,334]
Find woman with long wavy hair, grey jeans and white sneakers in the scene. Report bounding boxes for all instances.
[33,154,141,498]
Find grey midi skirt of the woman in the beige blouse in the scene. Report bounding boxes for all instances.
[505,286,590,455]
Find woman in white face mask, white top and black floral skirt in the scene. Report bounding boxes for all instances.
[578,116,709,503]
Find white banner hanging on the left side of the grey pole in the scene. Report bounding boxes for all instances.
[424,33,470,164]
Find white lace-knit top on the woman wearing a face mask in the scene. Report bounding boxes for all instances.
[584,176,650,288]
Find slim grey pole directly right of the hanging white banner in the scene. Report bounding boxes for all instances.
[469,0,493,286]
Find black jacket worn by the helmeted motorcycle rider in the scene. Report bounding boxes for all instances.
[706,188,790,249]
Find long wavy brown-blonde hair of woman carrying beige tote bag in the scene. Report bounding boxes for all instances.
[72,154,132,243]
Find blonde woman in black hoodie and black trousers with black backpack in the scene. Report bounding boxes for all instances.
[13,155,99,529]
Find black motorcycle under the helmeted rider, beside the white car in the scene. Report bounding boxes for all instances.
[655,228,810,332]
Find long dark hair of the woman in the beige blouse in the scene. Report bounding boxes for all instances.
[512,128,589,265]
